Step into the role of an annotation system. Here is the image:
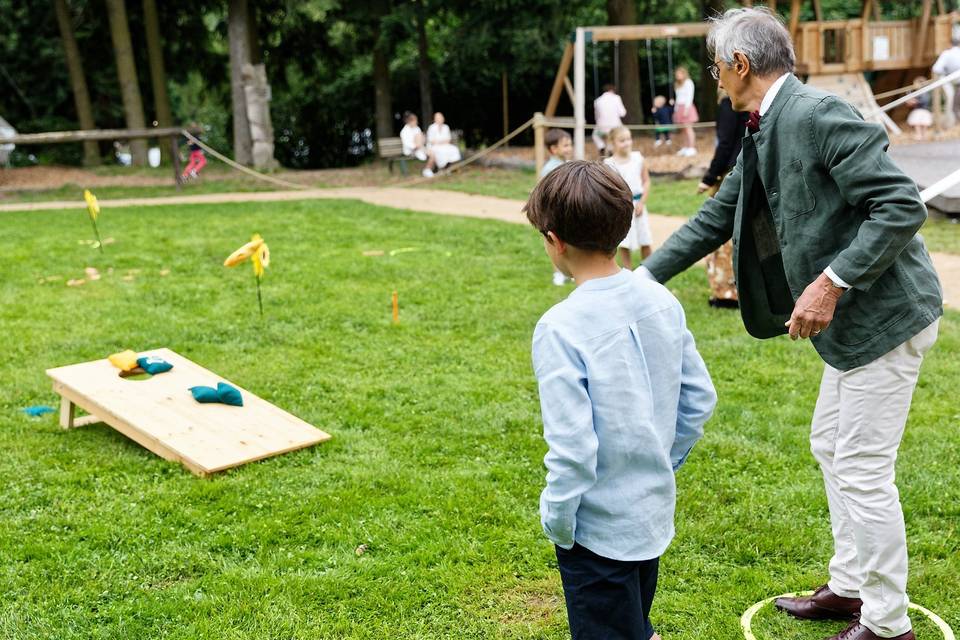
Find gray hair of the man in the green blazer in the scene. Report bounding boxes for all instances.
[707,7,797,77]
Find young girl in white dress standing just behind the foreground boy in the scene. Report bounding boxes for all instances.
[603,127,653,269]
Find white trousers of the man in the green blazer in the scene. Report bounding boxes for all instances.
[810,320,940,637]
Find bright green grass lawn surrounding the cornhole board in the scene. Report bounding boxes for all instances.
[0,201,960,640]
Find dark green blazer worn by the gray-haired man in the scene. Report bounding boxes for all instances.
[644,75,943,371]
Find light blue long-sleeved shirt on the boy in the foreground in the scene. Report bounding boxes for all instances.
[533,270,717,560]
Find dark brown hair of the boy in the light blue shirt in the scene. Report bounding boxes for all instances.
[523,160,633,256]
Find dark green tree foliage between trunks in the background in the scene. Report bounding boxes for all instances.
[0,0,960,168]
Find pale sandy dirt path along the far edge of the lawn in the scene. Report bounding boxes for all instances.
[0,187,960,307]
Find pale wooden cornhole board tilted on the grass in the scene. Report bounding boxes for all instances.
[47,349,330,476]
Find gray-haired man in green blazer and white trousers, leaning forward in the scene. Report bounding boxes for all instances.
[644,9,943,640]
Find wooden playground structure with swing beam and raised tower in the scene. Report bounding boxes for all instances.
[534,0,960,165]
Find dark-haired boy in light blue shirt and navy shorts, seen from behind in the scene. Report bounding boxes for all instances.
[524,161,716,640]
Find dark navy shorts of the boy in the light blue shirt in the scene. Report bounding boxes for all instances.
[556,544,660,640]
